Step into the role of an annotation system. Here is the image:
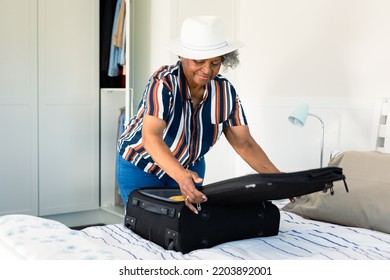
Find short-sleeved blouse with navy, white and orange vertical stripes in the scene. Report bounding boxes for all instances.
[118,61,247,178]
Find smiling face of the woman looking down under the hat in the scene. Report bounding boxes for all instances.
[180,56,222,87]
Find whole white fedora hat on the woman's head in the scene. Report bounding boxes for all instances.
[171,16,244,59]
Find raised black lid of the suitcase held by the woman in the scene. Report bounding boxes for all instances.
[200,167,348,205]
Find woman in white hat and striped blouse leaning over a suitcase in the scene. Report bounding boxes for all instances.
[117,16,279,213]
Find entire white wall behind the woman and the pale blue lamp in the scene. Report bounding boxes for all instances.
[132,0,390,181]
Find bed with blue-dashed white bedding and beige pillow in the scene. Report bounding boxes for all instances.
[0,151,390,260]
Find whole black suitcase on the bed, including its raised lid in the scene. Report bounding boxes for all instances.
[125,167,348,253]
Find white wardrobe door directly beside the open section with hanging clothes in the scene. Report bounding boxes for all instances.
[38,0,99,216]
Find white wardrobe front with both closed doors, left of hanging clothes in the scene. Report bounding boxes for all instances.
[0,0,99,216]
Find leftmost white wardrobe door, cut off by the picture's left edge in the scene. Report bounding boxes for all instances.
[0,0,38,215]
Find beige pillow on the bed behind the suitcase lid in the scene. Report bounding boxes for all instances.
[283,151,390,233]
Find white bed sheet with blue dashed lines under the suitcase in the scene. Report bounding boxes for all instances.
[0,211,390,260]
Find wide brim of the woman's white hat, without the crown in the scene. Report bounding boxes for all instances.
[170,39,244,59]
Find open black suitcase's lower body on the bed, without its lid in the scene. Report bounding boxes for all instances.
[124,188,280,254]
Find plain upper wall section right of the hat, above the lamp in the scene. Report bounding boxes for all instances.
[239,0,390,98]
